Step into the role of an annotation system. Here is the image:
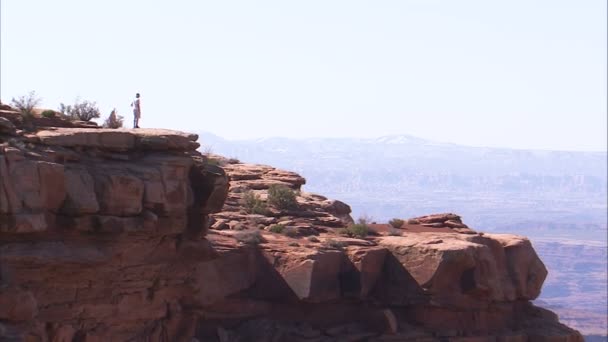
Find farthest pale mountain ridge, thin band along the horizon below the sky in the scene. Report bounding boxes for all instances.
[200,132,607,178]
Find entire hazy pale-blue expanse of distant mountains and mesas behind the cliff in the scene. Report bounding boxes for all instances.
[200,132,608,238]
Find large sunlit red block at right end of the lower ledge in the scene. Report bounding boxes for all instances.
[379,233,547,307]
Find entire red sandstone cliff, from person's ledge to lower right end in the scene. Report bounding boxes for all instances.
[0,116,582,342]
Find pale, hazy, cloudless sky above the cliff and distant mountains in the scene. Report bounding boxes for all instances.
[0,0,607,150]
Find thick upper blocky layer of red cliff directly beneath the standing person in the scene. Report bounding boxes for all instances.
[0,128,228,233]
